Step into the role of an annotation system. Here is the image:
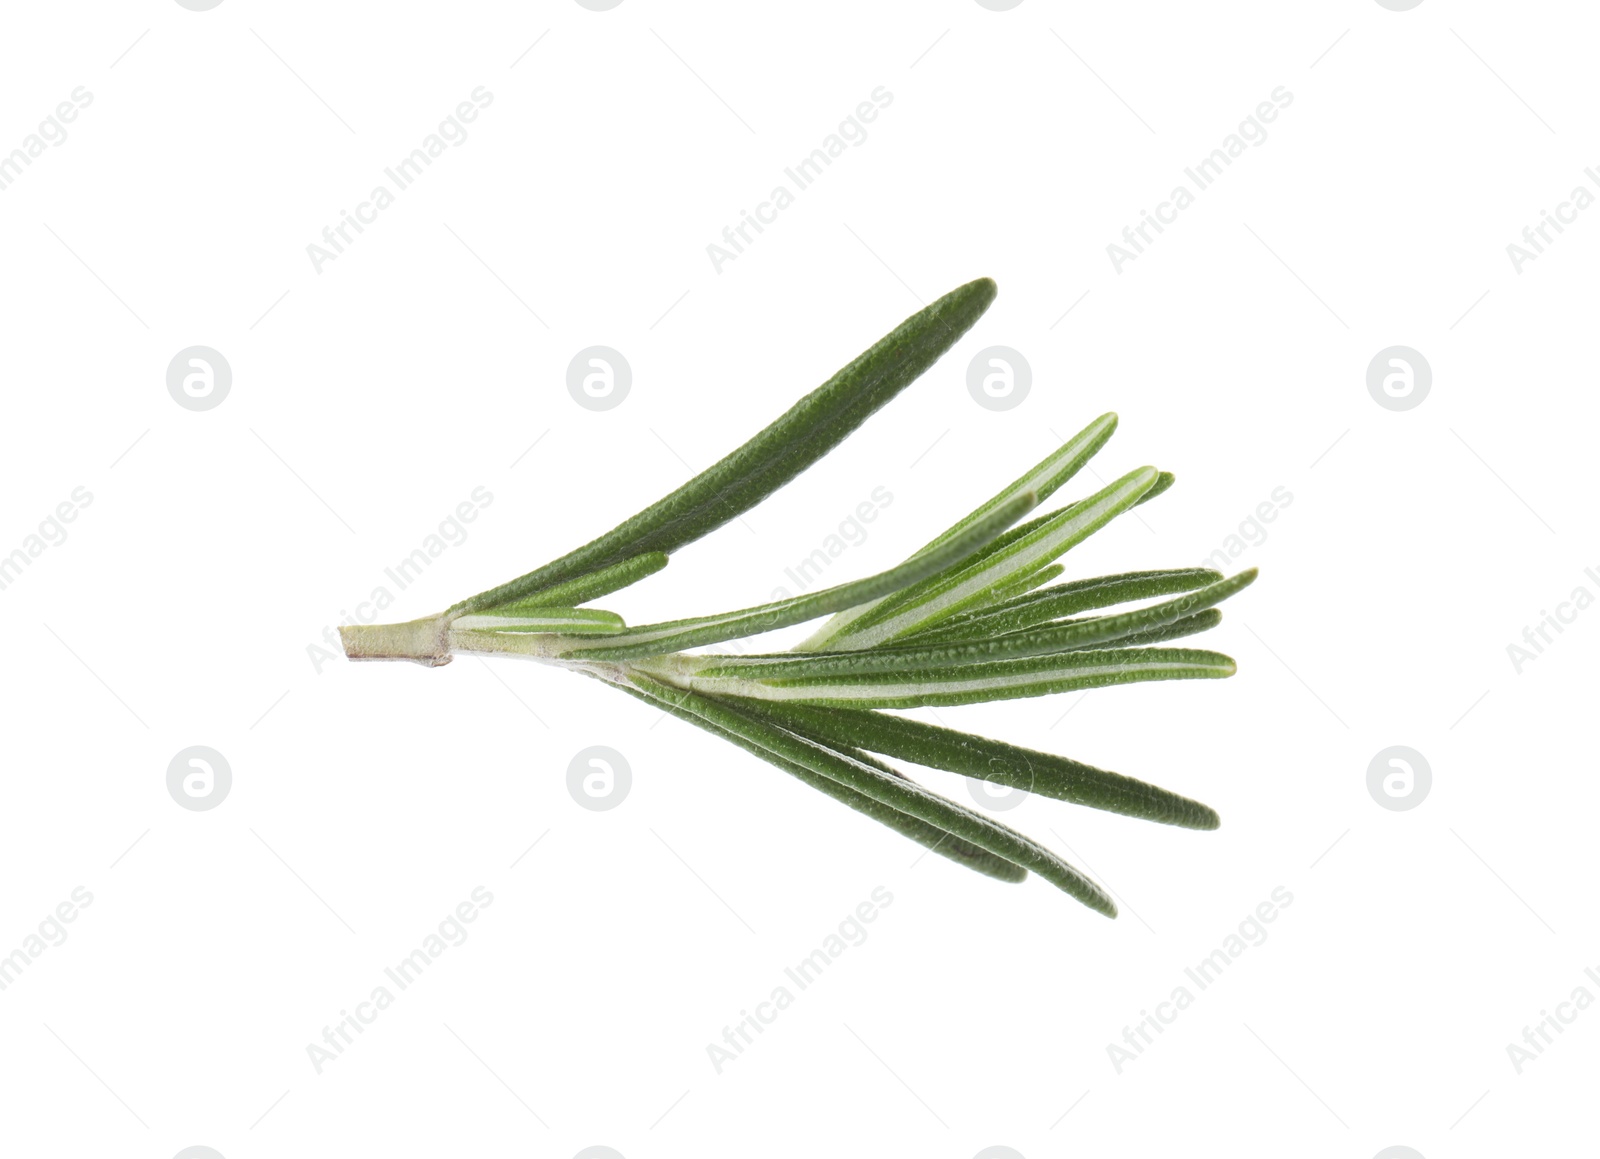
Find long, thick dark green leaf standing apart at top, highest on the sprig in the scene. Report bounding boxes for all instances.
[450,279,995,613]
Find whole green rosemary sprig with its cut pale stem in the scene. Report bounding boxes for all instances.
[341,279,1256,917]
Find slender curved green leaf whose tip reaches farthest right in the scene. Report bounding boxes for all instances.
[707,568,1256,680]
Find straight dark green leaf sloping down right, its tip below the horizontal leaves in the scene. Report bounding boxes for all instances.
[732,701,1221,829]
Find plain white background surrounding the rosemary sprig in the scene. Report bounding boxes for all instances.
[0,0,1600,1159]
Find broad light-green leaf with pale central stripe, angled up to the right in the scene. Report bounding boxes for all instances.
[806,467,1158,652]
